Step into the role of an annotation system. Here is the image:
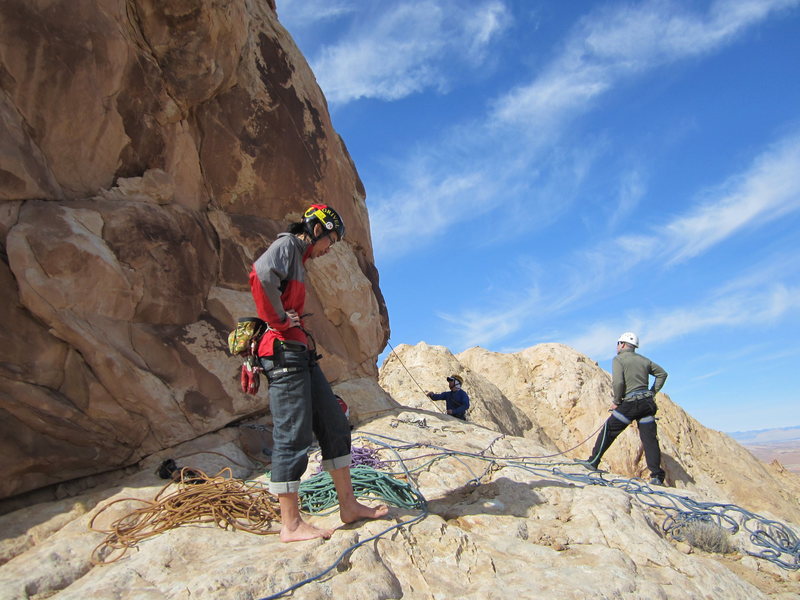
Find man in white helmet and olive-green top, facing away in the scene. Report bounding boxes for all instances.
[577,332,667,485]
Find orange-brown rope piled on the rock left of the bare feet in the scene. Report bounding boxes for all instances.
[89,467,280,565]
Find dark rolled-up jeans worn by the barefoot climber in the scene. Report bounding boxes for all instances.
[261,350,351,494]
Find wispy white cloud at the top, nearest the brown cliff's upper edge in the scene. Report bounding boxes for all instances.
[311,0,511,105]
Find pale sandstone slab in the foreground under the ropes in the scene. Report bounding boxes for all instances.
[0,406,800,600]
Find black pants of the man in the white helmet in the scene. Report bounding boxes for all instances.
[588,397,665,481]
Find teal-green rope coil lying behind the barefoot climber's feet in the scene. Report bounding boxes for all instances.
[299,466,425,514]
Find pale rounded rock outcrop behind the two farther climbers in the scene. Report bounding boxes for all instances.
[380,343,800,523]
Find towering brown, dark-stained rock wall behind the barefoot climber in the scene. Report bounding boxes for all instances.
[0,0,388,498]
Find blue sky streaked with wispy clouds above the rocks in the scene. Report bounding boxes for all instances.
[278,0,800,431]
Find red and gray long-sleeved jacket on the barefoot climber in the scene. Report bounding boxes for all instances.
[250,233,311,356]
